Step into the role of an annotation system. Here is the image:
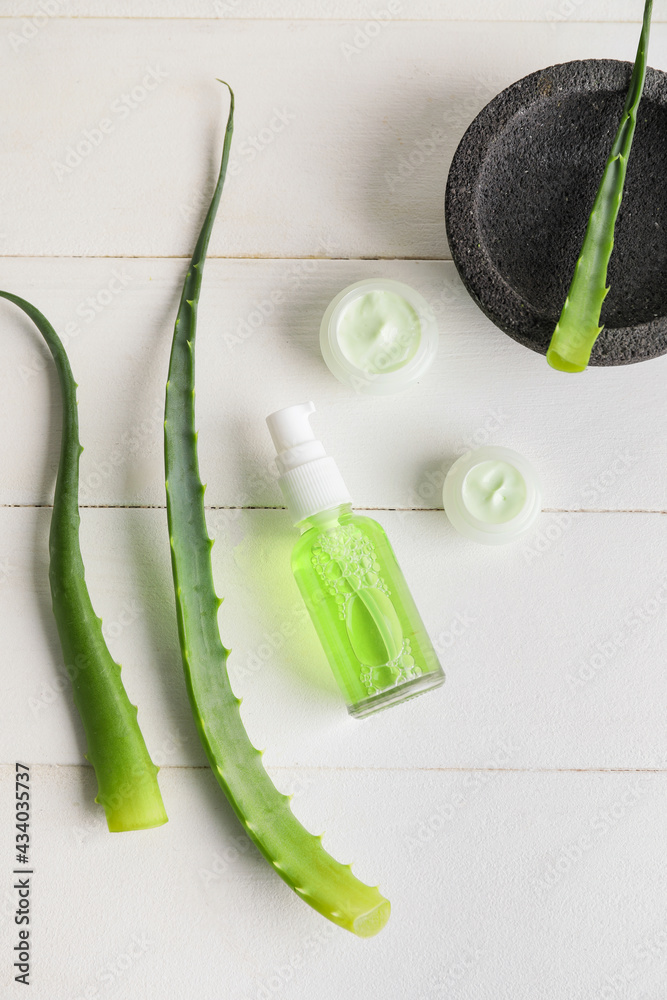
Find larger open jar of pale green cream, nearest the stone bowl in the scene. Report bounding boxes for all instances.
[320,278,438,396]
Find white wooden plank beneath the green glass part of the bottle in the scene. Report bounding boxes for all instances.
[0,508,667,769]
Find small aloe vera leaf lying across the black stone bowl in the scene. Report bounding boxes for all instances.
[547,0,653,372]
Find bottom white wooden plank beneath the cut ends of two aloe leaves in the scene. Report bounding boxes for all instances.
[0,767,667,1000]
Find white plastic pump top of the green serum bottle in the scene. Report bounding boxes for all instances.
[266,403,352,524]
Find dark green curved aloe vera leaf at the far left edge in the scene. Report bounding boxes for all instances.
[0,291,167,833]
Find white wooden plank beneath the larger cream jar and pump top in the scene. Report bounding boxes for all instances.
[5,259,667,510]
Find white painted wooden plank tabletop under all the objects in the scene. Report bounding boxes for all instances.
[0,0,667,1000]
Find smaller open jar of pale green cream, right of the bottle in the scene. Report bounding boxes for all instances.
[442,446,542,545]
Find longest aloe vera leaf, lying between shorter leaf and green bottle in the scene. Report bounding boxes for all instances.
[164,81,390,937]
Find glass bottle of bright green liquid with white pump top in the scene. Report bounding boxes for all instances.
[266,403,445,718]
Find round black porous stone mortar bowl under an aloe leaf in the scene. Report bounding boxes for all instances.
[445,59,667,365]
